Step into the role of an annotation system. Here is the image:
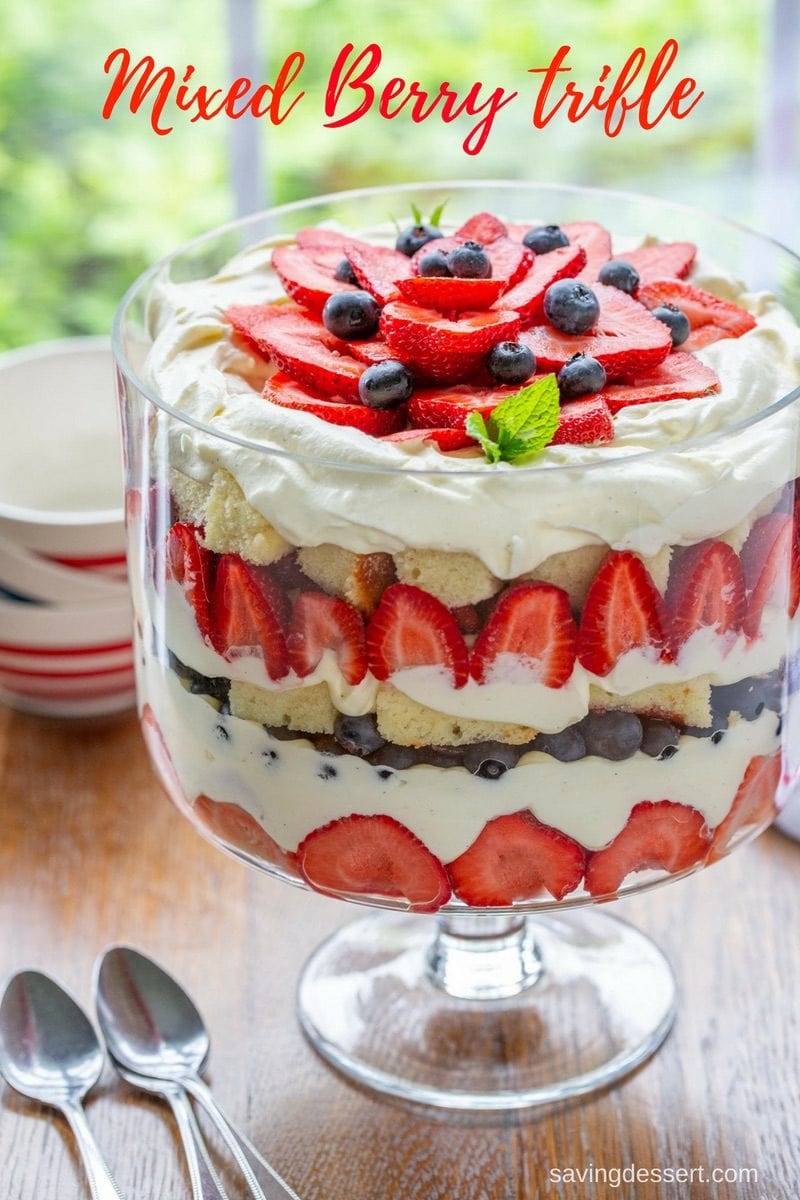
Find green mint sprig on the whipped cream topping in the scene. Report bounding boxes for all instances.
[465,374,559,462]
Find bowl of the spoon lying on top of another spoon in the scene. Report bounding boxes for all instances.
[95,946,210,1080]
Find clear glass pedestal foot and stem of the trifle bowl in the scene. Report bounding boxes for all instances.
[297,910,675,1111]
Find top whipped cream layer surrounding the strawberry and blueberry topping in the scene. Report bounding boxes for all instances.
[145,229,800,580]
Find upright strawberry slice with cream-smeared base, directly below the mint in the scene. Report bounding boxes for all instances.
[469,583,578,688]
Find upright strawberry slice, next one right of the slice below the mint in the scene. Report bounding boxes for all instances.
[578,550,669,676]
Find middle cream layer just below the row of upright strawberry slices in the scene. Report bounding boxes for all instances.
[163,581,790,733]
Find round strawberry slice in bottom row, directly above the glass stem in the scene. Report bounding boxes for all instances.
[447,809,587,908]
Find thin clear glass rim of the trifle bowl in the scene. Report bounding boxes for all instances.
[112,179,800,479]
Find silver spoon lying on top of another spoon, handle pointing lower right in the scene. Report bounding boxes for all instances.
[95,946,299,1200]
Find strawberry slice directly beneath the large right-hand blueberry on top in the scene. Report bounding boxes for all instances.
[519,283,672,379]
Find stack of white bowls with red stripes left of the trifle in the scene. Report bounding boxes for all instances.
[0,337,136,716]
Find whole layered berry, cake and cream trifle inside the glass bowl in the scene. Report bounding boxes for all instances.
[130,199,800,911]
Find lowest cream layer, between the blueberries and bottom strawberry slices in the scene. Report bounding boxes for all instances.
[142,658,778,863]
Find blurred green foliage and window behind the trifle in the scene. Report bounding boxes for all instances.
[0,0,786,348]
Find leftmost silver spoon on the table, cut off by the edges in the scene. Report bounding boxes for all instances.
[0,971,122,1200]
